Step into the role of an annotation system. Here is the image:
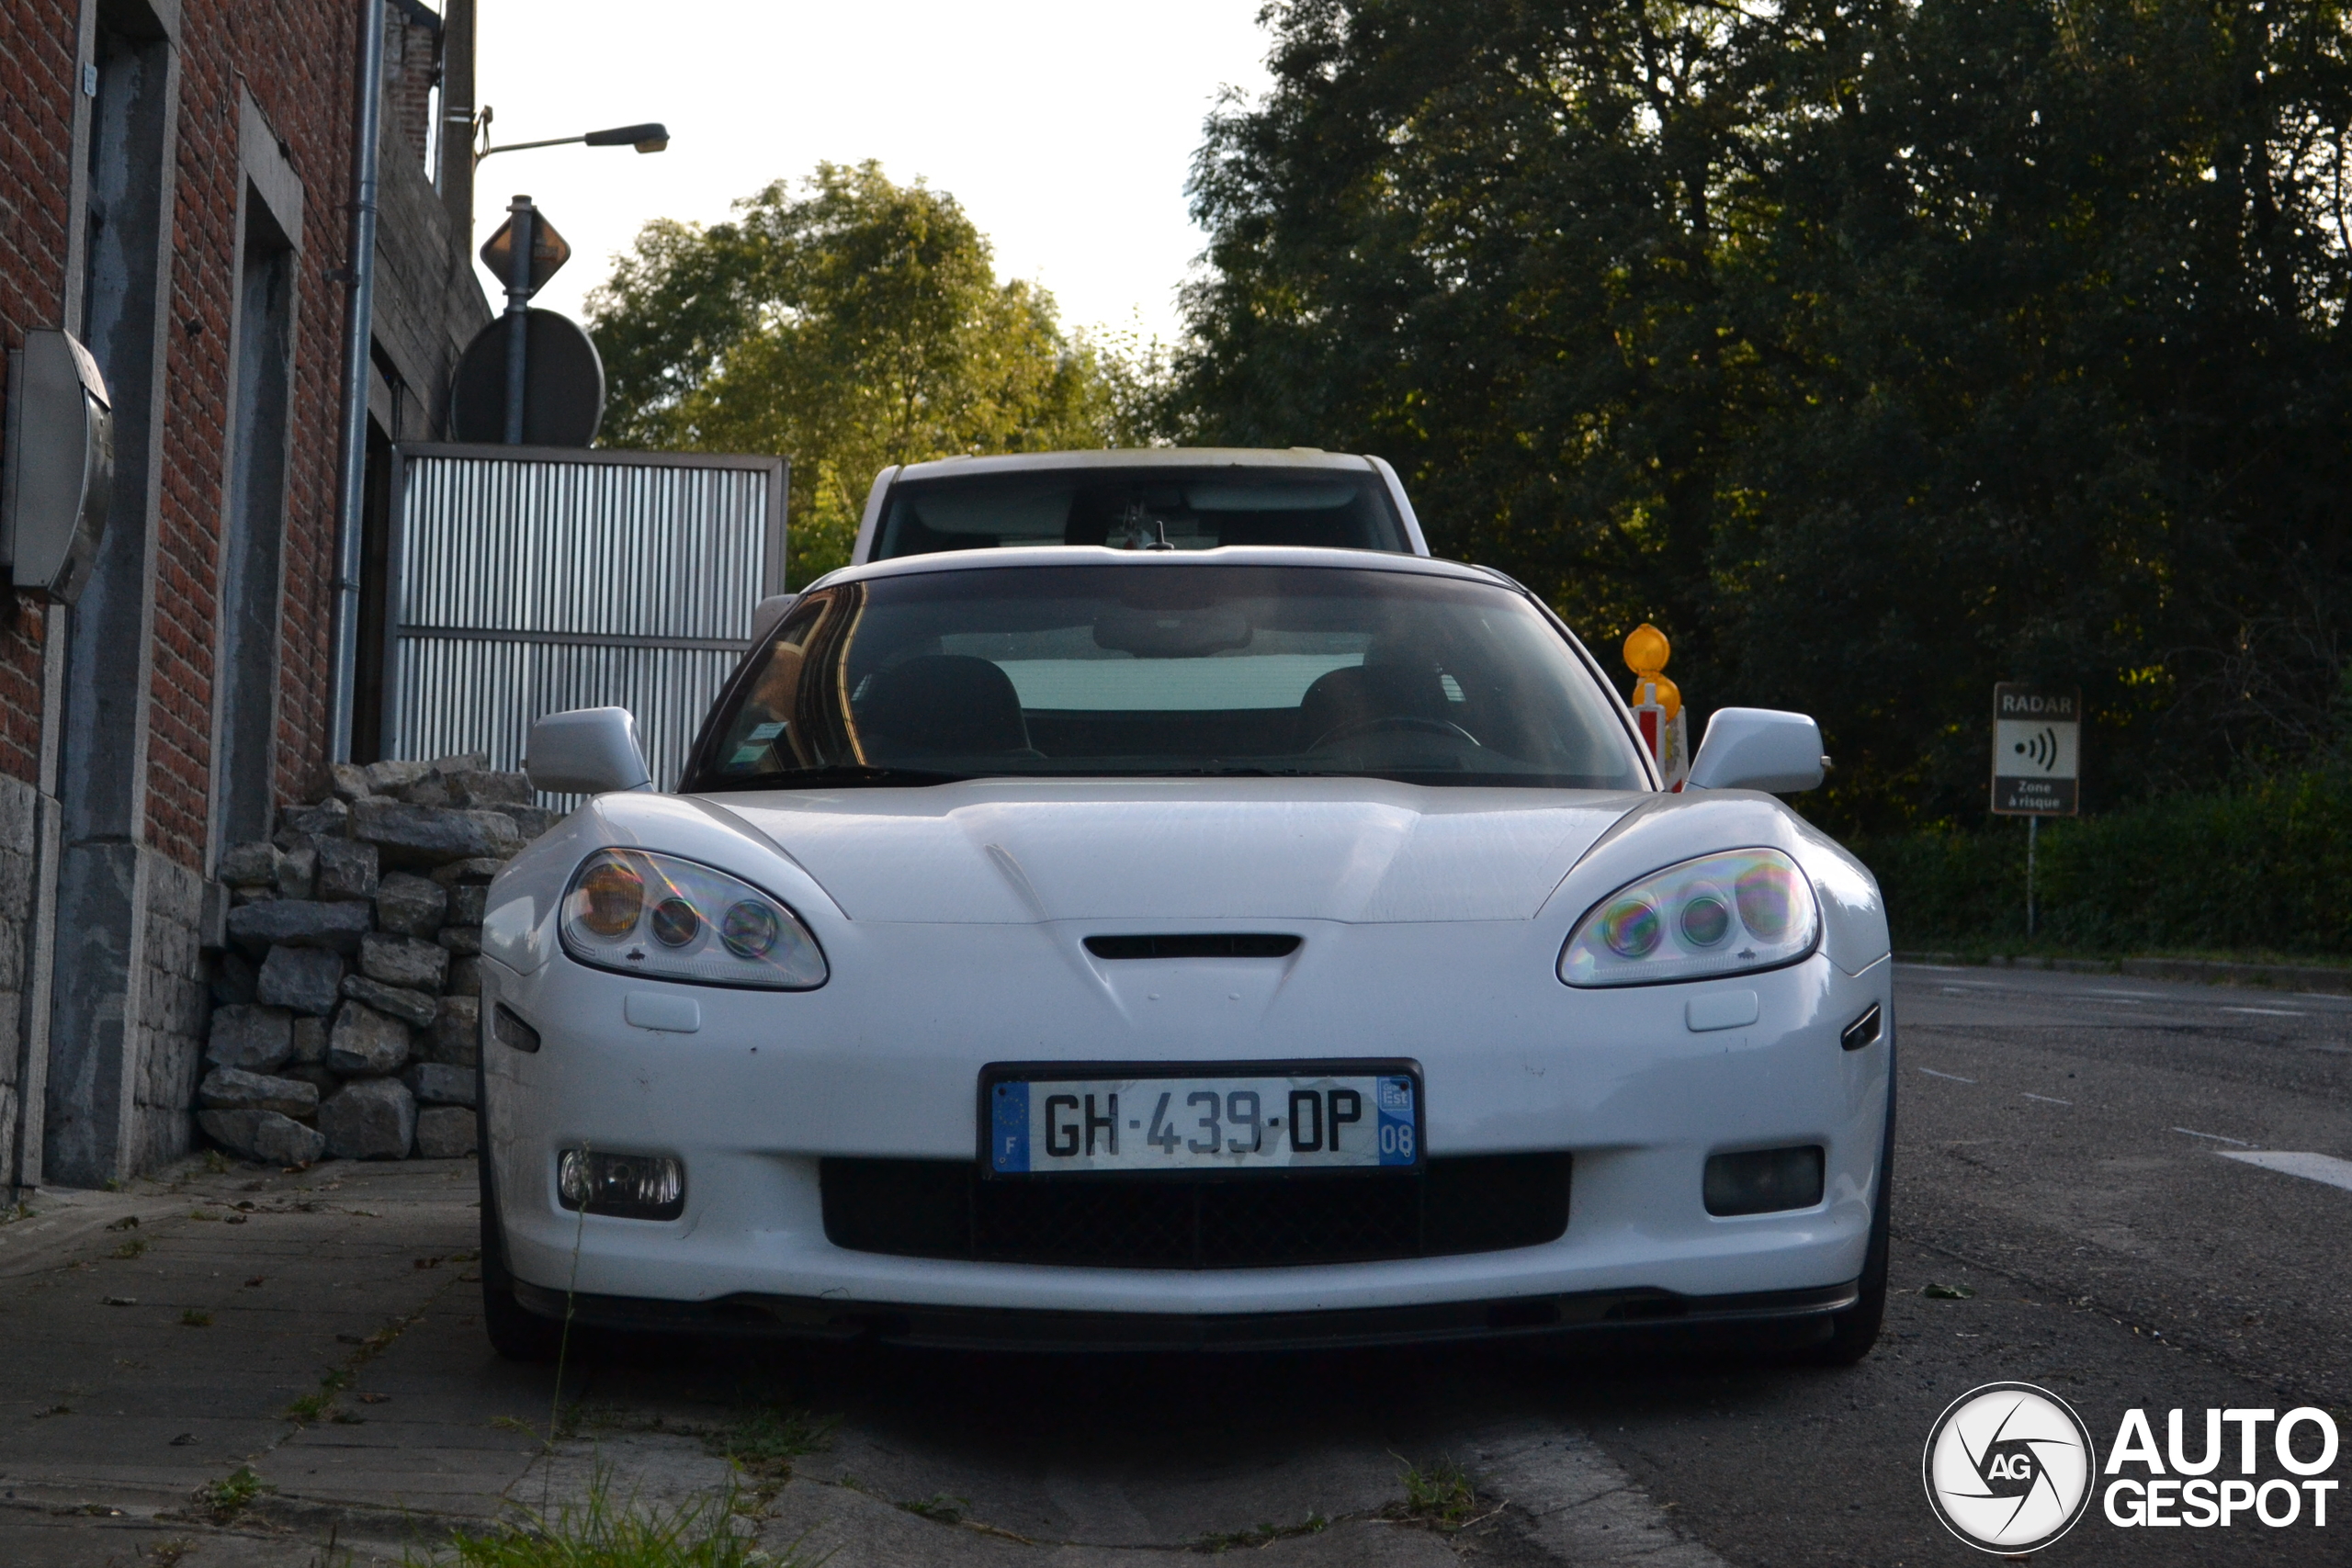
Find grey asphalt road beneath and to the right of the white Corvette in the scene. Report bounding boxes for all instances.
[591,966,2352,1568]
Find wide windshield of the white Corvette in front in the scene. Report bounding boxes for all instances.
[684,558,1649,792]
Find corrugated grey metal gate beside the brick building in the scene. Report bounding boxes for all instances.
[381,445,786,790]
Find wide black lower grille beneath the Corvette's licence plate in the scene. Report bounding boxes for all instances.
[819,1155,1569,1269]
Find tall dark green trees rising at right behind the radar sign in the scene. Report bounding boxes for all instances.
[1185,0,2352,832]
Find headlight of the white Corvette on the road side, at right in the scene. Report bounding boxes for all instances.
[1559,849,1820,985]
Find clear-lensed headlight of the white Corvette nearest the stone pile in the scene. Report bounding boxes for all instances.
[560,849,826,992]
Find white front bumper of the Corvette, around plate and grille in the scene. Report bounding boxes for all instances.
[482,921,1894,1347]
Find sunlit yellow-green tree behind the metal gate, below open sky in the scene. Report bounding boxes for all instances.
[588,163,1158,583]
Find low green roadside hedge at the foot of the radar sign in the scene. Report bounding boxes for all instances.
[1851,766,2352,957]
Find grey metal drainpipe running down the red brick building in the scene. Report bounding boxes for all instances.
[327,0,383,761]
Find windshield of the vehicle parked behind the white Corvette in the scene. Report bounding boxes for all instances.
[873,463,1411,562]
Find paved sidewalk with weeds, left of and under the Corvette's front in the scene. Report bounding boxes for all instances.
[0,1161,1719,1568]
